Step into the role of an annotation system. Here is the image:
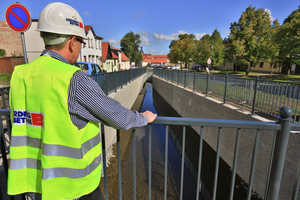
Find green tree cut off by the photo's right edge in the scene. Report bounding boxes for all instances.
[276,6,300,73]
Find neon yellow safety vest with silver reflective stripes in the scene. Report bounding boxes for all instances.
[8,56,102,200]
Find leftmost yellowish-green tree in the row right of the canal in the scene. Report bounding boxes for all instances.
[168,34,195,67]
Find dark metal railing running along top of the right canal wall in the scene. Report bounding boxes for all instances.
[154,69,300,122]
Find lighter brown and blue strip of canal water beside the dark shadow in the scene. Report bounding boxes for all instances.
[101,83,196,200]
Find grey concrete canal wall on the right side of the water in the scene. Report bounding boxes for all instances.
[152,76,300,199]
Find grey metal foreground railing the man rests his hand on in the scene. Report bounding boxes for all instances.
[0,107,300,200]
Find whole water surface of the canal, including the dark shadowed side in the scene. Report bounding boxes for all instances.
[101,83,256,200]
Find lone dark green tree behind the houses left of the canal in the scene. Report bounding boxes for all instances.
[120,31,143,64]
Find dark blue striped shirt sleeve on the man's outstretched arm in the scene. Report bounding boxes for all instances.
[71,71,148,130]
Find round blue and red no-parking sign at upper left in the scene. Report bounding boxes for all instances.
[5,3,31,32]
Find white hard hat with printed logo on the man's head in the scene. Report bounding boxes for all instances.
[37,2,87,39]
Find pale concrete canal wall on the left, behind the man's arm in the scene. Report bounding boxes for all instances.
[104,74,147,165]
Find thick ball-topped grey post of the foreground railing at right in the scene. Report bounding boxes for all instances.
[265,107,293,200]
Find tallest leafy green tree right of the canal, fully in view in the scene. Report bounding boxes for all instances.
[229,6,271,75]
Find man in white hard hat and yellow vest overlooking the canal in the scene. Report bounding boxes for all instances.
[8,3,156,200]
